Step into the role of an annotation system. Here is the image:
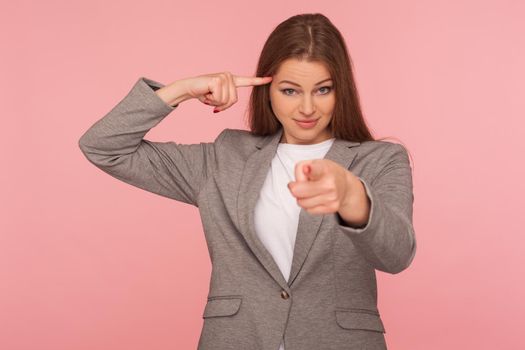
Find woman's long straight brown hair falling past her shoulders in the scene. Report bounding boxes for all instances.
[248,13,380,142]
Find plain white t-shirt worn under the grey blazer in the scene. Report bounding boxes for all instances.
[254,138,335,350]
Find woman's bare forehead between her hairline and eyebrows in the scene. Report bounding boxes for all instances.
[274,58,331,85]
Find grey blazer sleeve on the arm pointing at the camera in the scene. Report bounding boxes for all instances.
[337,143,416,274]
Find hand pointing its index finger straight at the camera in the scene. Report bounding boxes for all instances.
[288,159,370,226]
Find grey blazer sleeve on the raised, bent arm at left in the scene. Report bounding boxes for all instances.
[78,77,226,207]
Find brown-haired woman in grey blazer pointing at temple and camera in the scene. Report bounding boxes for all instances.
[79,14,416,350]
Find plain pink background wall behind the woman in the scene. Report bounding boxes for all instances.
[0,0,525,350]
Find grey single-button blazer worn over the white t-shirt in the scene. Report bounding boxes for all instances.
[79,77,416,350]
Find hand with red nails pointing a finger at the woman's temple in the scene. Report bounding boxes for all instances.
[184,72,272,112]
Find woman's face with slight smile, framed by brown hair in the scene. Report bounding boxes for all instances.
[270,58,335,145]
